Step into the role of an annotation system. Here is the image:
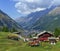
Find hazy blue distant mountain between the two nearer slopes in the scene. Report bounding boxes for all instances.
[16,7,54,29]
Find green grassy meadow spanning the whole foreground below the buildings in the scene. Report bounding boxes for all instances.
[0,32,60,51]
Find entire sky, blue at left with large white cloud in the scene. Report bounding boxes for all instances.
[0,0,60,19]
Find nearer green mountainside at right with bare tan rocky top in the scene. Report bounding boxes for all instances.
[31,7,60,31]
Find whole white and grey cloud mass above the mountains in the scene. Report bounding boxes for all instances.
[13,0,60,14]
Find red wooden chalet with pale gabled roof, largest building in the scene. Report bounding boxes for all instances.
[37,31,54,41]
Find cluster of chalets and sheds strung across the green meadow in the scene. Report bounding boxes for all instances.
[8,31,60,47]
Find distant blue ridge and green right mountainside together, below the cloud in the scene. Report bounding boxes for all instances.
[16,6,60,31]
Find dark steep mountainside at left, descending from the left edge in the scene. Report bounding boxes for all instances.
[0,10,22,31]
